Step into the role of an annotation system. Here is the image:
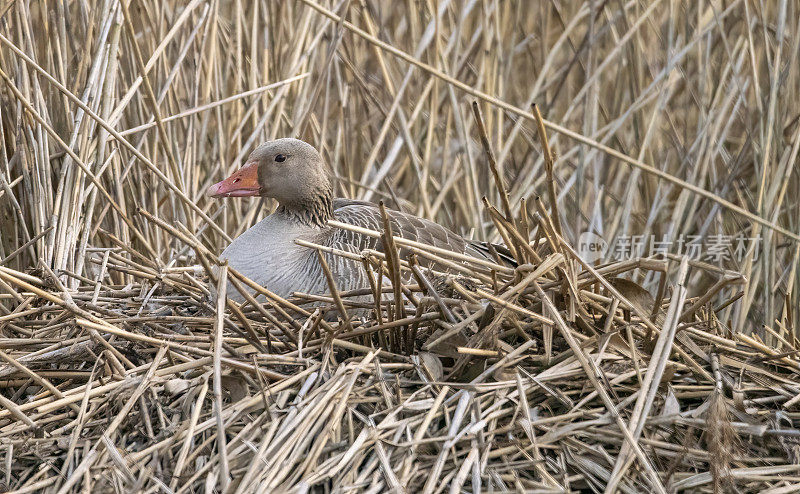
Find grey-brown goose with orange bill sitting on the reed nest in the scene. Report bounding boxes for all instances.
[207,138,506,302]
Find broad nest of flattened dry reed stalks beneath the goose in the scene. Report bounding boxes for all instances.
[0,202,800,492]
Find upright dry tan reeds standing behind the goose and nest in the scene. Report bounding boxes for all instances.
[0,1,800,330]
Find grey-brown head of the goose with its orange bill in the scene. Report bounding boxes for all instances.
[207,138,332,211]
